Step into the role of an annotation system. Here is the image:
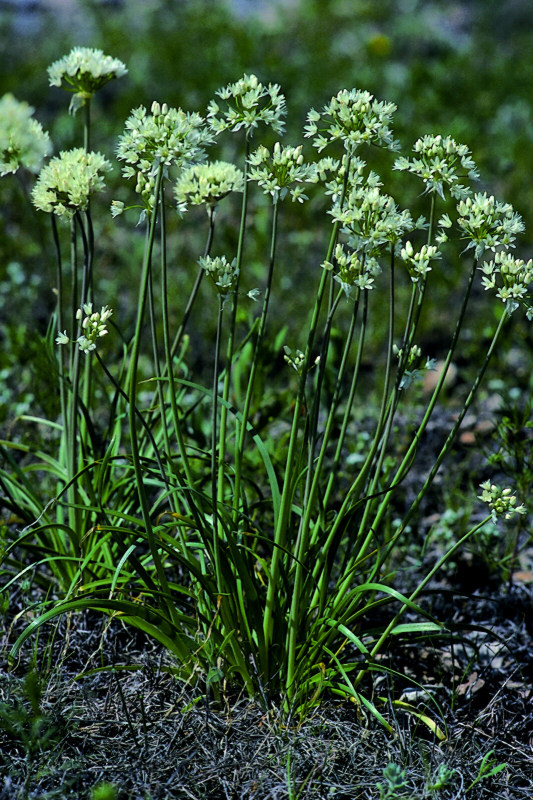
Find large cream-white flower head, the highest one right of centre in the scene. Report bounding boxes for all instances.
[304,89,398,154]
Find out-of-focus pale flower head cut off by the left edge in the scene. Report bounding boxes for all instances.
[0,94,52,175]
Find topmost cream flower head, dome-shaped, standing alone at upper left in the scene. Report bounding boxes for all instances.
[48,47,128,113]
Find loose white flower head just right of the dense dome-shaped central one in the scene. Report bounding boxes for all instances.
[248,142,317,203]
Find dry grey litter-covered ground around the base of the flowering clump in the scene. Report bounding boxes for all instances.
[0,582,533,800]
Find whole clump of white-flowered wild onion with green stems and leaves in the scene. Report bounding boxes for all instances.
[0,53,533,724]
